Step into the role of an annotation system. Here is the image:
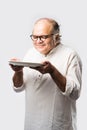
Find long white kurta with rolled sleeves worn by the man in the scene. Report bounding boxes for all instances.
[14,44,82,130]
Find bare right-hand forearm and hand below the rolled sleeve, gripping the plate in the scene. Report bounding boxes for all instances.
[30,61,66,92]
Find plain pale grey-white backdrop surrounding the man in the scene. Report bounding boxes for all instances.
[0,0,87,130]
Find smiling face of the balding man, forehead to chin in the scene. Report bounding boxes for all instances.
[33,21,54,55]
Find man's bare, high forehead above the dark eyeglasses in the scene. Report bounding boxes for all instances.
[33,20,53,35]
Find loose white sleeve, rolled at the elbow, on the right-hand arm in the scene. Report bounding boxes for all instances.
[63,53,82,100]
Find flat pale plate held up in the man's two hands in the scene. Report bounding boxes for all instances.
[9,61,42,67]
